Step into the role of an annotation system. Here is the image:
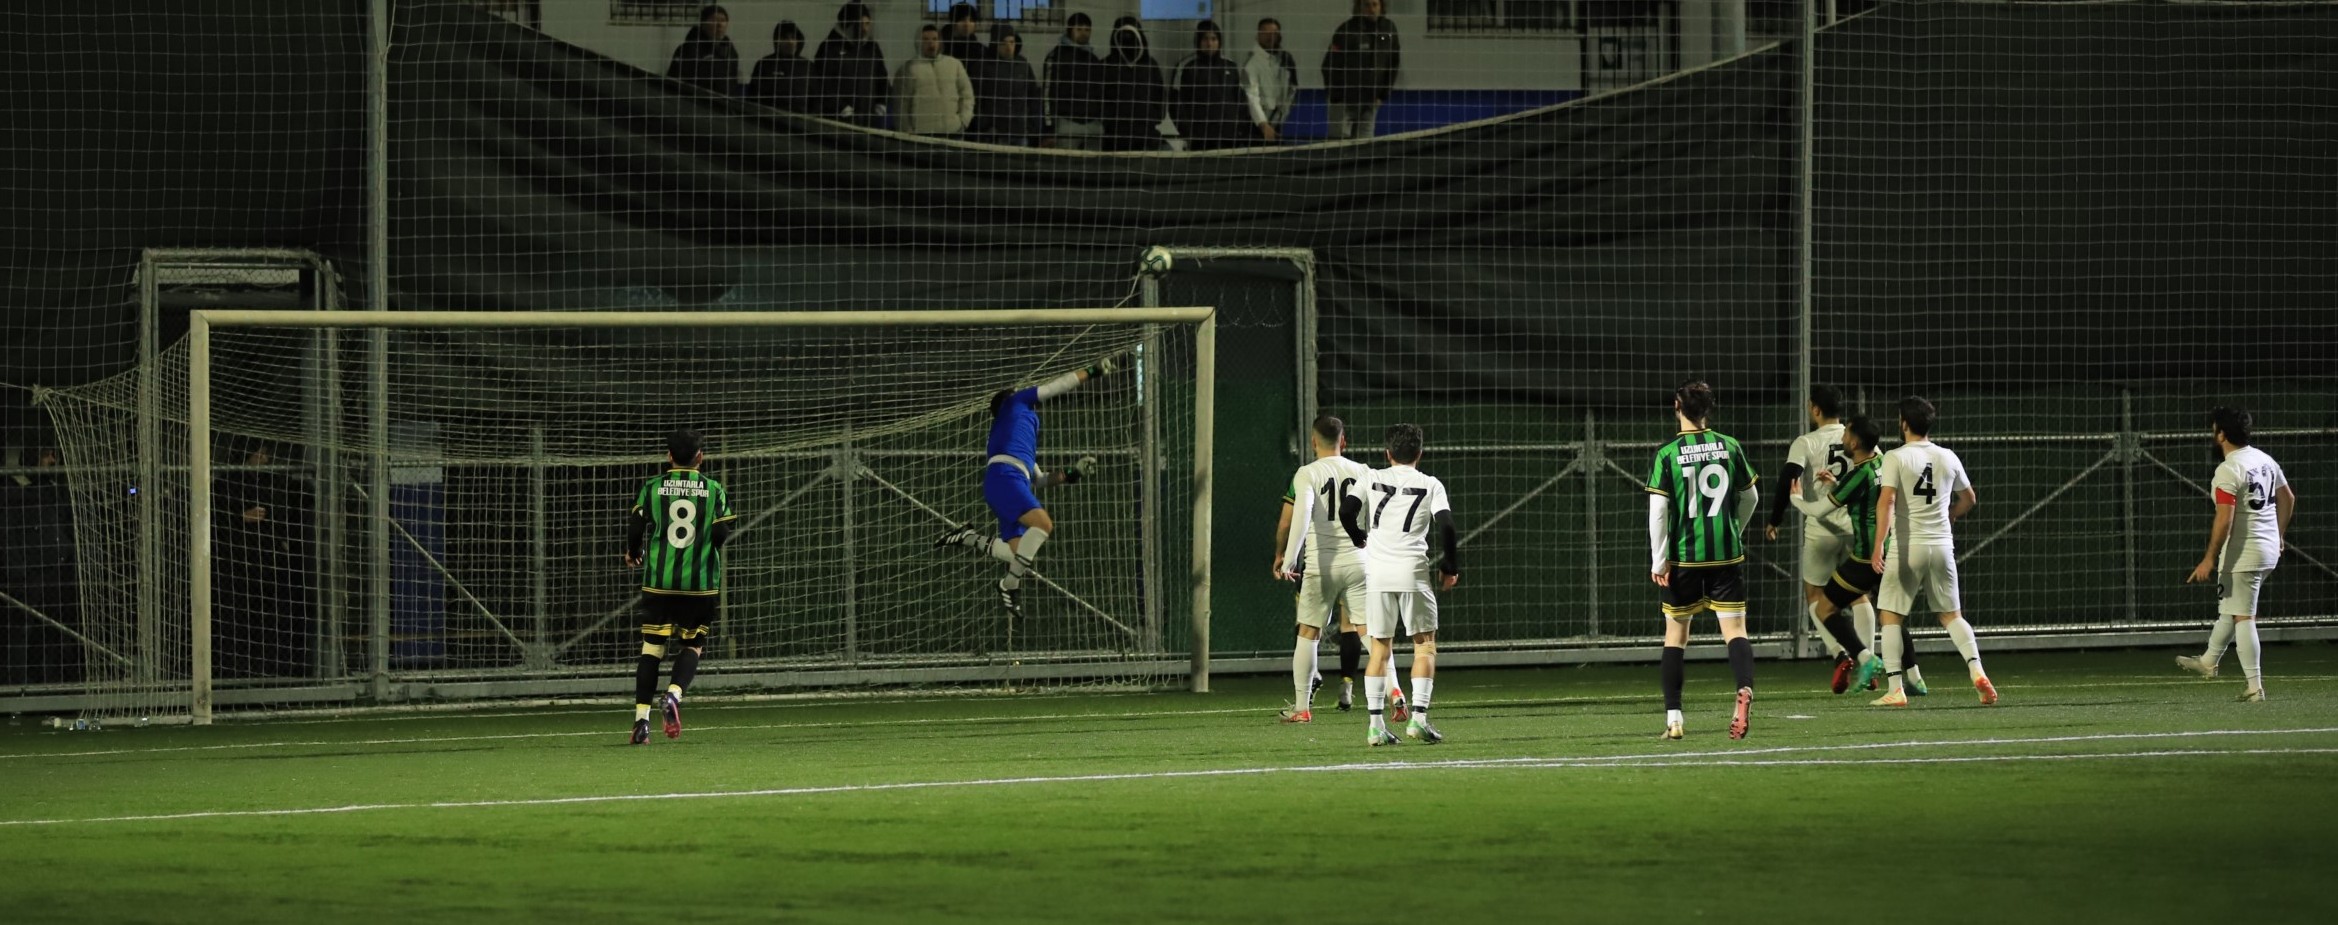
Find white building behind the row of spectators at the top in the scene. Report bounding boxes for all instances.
[535,0,1749,100]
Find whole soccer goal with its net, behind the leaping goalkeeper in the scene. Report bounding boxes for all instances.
[47,308,1216,722]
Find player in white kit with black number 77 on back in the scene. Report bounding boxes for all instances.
[1340,423,1461,745]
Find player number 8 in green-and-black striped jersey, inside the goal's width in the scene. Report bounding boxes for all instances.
[624,430,736,745]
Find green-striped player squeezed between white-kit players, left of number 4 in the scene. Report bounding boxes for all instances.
[1793,413,1929,696]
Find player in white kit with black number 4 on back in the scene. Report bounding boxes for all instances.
[1870,395,1997,708]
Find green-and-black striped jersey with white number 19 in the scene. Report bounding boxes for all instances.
[1648,430,1758,568]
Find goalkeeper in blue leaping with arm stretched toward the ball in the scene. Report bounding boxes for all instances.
[933,355,1120,617]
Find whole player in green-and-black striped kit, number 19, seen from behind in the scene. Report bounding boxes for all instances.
[1648,381,1761,738]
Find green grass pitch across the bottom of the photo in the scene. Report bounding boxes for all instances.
[0,645,2338,925]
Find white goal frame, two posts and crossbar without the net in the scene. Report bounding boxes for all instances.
[187,306,1218,726]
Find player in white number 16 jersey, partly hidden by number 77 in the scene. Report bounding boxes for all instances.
[1274,413,1405,722]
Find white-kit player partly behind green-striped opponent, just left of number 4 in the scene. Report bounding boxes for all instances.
[1763,385,1875,694]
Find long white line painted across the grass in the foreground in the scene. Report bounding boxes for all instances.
[0,729,2338,827]
